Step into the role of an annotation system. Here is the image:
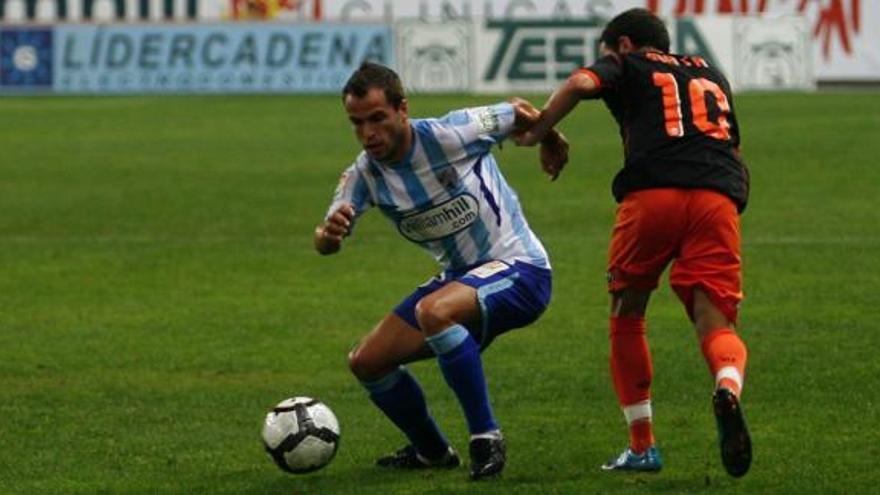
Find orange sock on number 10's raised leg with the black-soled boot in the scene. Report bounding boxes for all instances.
[700,328,748,396]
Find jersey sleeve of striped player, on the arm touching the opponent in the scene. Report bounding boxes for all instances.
[440,103,515,149]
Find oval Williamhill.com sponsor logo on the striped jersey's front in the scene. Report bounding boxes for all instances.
[397,194,480,242]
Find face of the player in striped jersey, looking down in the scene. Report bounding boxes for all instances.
[344,88,409,162]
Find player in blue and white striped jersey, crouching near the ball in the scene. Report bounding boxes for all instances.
[315,63,568,480]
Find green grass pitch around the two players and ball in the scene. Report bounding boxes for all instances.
[0,93,880,494]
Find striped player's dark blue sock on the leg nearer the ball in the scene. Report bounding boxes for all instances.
[361,366,449,459]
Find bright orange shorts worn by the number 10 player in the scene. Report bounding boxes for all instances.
[608,188,743,322]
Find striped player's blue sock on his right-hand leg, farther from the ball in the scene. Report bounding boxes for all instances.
[427,325,498,435]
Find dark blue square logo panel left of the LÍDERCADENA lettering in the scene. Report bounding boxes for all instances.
[0,29,52,88]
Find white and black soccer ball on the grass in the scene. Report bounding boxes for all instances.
[263,397,339,473]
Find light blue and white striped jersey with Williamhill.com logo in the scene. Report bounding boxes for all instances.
[327,103,550,270]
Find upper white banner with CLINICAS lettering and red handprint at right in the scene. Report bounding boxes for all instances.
[316,0,880,81]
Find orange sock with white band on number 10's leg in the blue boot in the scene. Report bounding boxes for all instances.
[610,316,654,453]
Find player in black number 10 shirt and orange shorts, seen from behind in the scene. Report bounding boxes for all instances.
[517,9,752,477]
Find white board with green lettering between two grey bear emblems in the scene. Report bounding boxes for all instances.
[394,17,814,94]
